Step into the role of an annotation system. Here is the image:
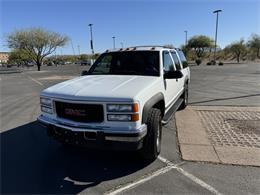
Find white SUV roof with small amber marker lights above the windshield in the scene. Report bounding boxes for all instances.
[103,45,180,52]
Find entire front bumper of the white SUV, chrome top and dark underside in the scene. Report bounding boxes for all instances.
[38,115,147,150]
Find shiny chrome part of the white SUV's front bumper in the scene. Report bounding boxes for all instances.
[37,115,147,142]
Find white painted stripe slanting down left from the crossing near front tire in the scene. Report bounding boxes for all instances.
[105,165,174,195]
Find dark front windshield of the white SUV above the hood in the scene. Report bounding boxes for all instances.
[88,51,160,76]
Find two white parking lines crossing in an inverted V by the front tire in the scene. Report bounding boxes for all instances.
[105,156,221,195]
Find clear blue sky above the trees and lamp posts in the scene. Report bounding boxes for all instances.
[0,0,260,54]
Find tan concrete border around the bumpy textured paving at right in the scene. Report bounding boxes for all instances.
[176,106,260,166]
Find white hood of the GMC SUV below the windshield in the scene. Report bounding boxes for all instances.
[42,75,160,101]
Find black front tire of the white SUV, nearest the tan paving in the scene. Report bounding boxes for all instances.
[140,108,162,161]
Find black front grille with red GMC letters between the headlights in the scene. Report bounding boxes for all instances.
[55,101,104,123]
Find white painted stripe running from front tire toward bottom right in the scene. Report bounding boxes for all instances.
[158,156,221,195]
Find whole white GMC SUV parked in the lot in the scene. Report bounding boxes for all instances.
[38,46,190,160]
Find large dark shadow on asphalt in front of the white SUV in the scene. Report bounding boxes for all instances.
[1,121,149,194]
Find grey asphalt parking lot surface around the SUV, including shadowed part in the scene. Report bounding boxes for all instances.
[0,64,260,194]
